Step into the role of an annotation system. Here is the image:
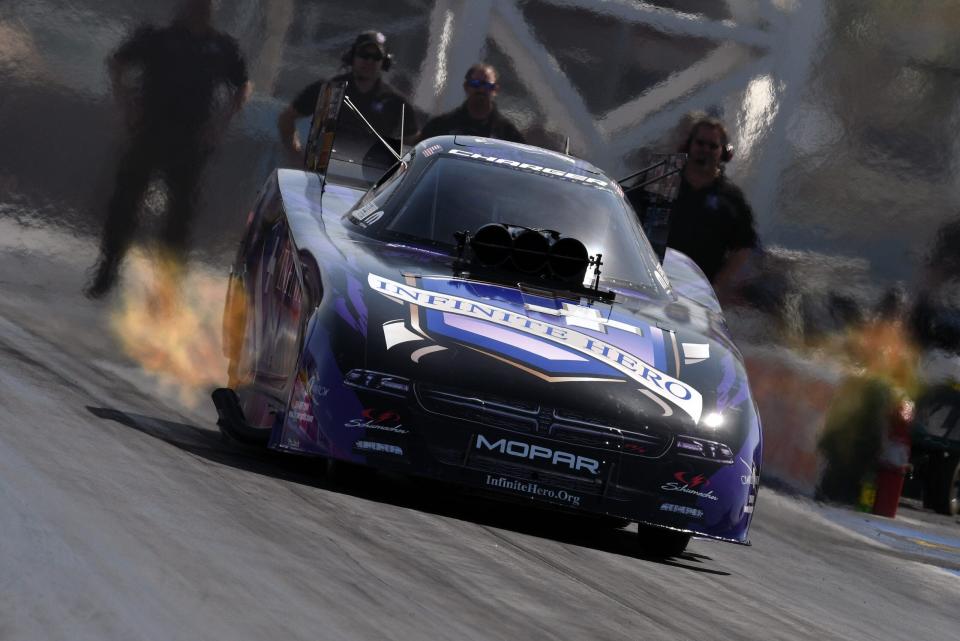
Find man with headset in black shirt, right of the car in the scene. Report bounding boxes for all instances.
[667,117,759,294]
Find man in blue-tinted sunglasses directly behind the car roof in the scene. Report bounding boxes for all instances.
[420,63,524,142]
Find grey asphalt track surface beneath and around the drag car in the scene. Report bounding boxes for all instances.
[0,220,960,641]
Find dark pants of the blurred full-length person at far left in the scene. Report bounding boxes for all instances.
[100,135,209,269]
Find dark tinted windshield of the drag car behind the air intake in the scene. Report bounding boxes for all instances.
[377,157,667,295]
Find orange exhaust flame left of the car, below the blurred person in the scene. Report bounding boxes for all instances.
[111,251,245,407]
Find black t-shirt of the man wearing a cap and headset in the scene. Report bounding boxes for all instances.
[290,72,417,140]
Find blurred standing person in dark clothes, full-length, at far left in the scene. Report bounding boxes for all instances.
[86,0,251,298]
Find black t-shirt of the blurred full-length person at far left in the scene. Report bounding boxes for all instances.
[113,22,247,136]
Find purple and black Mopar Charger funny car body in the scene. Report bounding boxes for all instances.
[214,136,761,554]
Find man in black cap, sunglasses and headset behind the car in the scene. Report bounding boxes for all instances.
[277,31,417,154]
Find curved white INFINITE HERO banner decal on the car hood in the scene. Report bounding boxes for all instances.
[367,274,703,423]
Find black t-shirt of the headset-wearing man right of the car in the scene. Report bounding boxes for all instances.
[667,176,757,281]
